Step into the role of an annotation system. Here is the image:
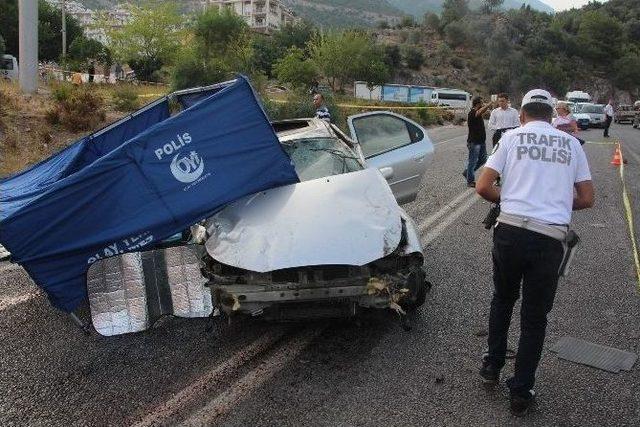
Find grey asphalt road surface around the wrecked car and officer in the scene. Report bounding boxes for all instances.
[0,125,640,426]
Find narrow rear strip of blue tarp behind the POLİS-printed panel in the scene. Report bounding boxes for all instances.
[0,98,169,221]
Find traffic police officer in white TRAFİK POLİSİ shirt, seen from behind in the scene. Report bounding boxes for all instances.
[476,89,593,416]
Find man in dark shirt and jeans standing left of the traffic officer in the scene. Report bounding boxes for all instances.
[462,96,491,187]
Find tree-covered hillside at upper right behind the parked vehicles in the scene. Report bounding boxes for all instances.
[377,0,640,103]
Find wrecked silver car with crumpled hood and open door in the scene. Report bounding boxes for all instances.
[204,112,433,319]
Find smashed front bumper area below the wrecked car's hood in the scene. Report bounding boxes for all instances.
[209,256,425,320]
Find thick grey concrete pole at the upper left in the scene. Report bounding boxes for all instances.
[18,0,38,93]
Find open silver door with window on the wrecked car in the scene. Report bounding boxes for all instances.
[348,111,433,204]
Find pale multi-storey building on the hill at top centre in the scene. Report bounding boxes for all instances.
[206,0,296,34]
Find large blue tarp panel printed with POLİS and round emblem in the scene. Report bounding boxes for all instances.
[0,77,298,311]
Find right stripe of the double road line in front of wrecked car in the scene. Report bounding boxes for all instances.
[180,328,324,426]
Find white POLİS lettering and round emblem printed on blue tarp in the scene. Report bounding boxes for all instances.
[154,132,211,191]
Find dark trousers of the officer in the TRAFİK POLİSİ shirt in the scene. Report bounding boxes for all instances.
[487,224,564,396]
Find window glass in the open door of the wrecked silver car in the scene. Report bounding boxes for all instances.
[353,114,416,158]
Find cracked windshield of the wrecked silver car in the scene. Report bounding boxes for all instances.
[282,138,363,181]
